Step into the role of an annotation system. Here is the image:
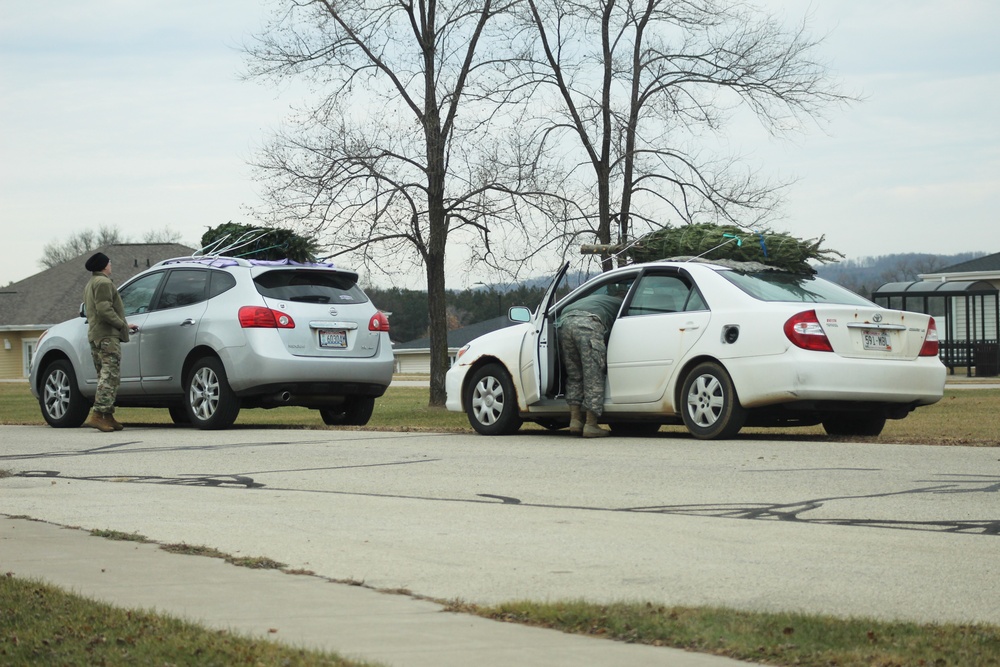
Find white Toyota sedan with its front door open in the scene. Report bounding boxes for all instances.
[446,261,946,439]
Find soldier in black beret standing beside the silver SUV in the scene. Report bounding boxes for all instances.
[83,252,138,433]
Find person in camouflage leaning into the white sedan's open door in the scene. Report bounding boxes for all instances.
[556,294,622,438]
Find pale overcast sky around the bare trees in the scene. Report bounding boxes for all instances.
[0,0,1000,289]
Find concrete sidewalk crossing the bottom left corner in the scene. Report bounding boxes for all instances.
[0,515,750,667]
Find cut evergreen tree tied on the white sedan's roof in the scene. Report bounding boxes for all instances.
[624,223,844,274]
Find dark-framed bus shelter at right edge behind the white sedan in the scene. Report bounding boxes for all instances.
[872,280,1000,377]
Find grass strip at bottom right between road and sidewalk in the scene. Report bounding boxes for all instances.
[449,601,1000,667]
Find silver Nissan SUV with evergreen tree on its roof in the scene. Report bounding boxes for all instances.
[30,257,393,429]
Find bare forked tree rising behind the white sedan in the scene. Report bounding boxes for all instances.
[518,0,850,268]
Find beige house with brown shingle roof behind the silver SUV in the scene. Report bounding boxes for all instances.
[0,243,194,379]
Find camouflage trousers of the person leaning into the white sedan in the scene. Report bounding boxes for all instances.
[558,313,608,417]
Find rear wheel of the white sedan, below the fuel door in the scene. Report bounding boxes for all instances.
[681,361,747,440]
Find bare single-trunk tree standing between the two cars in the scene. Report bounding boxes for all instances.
[247,0,552,405]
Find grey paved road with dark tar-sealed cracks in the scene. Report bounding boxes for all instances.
[0,426,1000,623]
